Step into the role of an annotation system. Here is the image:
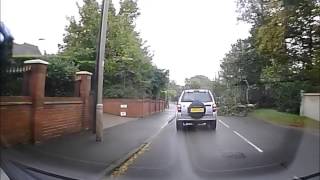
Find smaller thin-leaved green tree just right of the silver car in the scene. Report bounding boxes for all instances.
[221,38,267,103]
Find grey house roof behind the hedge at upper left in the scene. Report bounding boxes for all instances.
[12,43,41,57]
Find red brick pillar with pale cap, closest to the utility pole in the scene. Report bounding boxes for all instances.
[75,71,92,129]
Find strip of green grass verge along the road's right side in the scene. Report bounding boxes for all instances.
[249,109,320,130]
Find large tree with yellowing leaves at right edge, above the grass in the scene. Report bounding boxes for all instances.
[232,0,320,112]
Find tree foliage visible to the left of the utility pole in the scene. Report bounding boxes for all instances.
[59,0,101,72]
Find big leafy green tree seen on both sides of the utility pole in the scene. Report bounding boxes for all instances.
[60,0,169,98]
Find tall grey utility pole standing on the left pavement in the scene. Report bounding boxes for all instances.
[95,0,109,142]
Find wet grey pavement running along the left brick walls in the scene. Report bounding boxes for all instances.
[1,106,175,180]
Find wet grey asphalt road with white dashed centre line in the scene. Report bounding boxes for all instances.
[110,117,320,180]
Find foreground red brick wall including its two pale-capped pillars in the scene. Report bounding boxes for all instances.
[0,59,93,146]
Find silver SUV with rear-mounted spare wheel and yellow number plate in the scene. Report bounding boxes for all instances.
[176,89,217,130]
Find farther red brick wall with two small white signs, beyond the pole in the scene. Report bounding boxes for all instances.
[103,99,164,117]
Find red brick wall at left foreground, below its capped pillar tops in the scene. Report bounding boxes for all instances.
[0,96,92,146]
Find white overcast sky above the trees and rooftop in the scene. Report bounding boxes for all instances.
[1,0,250,85]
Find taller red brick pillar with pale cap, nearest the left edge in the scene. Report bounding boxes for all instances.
[24,59,49,143]
